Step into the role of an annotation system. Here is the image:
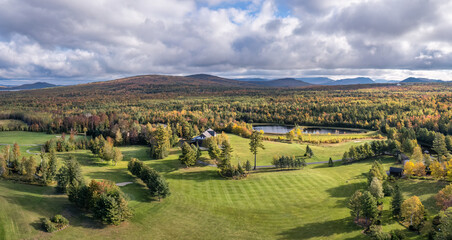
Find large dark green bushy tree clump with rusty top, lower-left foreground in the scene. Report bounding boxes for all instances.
[68,180,132,225]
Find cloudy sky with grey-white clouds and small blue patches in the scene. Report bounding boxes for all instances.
[0,0,452,84]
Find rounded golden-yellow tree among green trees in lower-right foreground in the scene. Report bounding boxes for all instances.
[402,196,424,228]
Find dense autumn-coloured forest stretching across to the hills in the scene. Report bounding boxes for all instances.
[0,76,452,143]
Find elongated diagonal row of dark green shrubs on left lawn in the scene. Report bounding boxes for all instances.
[127,158,171,201]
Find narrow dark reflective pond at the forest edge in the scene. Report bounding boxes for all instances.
[253,125,362,134]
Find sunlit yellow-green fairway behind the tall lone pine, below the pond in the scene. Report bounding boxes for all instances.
[228,134,372,166]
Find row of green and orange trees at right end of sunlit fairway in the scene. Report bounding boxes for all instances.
[342,140,397,164]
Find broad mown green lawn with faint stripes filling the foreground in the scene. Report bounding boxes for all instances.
[0,132,443,239]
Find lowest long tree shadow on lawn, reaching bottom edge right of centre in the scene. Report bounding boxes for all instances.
[278,217,359,239]
